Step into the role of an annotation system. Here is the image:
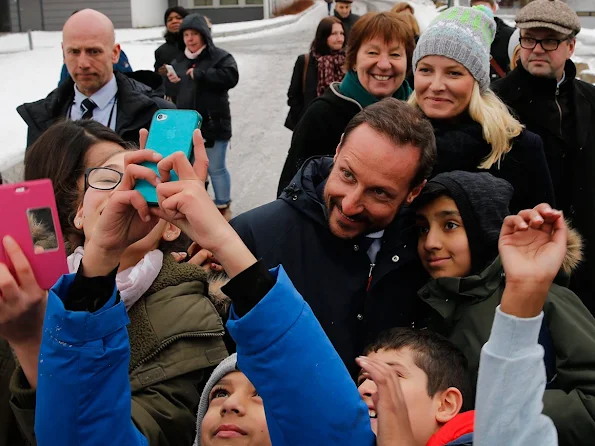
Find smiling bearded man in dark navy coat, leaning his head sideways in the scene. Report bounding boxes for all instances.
[231,98,436,376]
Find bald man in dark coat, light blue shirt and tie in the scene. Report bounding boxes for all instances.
[17,9,173,146]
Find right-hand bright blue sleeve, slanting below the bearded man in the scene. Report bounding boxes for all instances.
[227,266,376,446]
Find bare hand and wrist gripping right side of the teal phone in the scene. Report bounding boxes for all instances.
[151,130,256,277]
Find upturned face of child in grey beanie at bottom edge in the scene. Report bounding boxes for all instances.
[200,372,271,446]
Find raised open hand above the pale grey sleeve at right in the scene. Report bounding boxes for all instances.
[498,204,568,317]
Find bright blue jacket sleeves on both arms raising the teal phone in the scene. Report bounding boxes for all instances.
[35,267,376,446]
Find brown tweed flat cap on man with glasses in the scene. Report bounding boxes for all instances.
[515,0,581,34]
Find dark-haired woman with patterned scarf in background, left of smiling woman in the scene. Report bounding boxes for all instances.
[285,17,345,130]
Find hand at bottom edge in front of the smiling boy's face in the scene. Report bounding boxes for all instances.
[356,356,416,446]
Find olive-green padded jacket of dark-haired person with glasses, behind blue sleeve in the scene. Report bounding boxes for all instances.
[0,255,227,446]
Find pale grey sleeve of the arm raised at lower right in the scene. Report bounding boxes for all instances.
[473,306,558,446]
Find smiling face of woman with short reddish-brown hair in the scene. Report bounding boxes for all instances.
[355,37,407,99]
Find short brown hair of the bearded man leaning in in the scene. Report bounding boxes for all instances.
[341,98,437,187]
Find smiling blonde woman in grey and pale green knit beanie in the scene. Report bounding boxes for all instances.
[409,6,554,213]
